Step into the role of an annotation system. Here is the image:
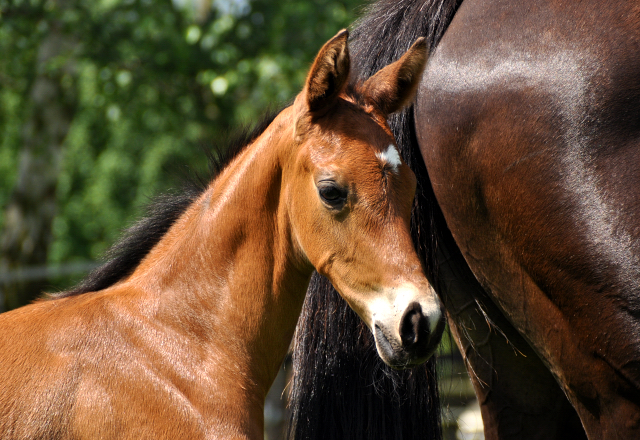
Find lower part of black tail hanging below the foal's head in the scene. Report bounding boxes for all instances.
[288,273,440,440]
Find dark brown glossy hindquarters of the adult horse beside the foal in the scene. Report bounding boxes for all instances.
[293,0,640,439]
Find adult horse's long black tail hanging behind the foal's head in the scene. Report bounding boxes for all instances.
[288,0,462,440]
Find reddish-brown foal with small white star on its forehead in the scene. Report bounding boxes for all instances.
[0,31,443,439]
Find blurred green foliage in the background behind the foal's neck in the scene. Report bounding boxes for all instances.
[0,0,361,274]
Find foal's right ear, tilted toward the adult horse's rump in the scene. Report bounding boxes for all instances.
[362,37,427,115]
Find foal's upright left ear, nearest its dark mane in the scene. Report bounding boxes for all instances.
[305,29,349,113]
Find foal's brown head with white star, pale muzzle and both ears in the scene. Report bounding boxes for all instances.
[285,31,444,367]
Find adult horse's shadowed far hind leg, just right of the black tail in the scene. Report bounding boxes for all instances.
[437,239,586,439]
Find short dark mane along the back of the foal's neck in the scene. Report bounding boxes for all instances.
[55,111,280,299]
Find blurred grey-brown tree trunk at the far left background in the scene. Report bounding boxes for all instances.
[0,1,78,308]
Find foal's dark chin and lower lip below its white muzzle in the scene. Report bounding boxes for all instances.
[373,320,444,370]
